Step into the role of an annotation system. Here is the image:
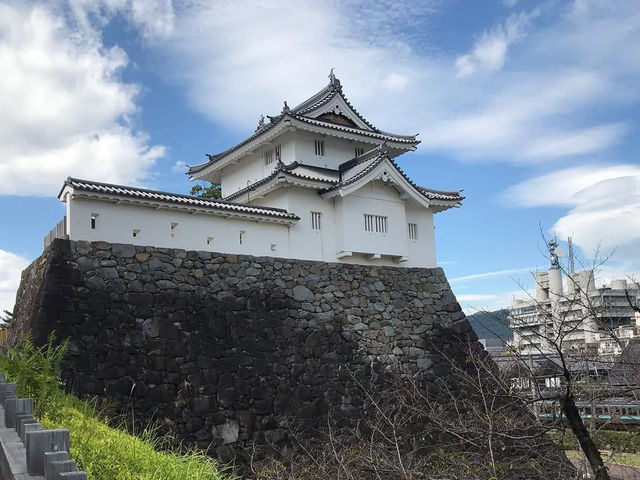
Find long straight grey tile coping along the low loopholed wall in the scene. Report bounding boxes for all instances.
[60,177,299,220]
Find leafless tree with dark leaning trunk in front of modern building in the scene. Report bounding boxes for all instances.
[476,239,638,480]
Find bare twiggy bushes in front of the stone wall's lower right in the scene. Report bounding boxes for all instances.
[251,343,574,480]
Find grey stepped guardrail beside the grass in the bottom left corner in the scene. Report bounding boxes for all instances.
[0,373,87,480]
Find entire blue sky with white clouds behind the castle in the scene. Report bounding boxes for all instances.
[0,0,640,311]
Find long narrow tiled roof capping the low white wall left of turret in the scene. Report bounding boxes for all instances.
[58,177,300,223]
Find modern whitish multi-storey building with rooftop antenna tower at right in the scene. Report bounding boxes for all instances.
[509,241,640,355]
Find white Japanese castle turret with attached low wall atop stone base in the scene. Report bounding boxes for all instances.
[50,72,464,267]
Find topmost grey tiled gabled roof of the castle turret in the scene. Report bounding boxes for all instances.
[187,72,420,178]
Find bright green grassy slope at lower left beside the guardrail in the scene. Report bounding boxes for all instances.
[0,338,233,480]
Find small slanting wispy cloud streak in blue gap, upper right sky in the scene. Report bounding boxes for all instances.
[456,9,539,77]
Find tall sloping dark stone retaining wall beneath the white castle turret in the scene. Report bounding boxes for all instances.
[11,239,475,458]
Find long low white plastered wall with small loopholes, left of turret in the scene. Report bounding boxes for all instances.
[67,198,290,257]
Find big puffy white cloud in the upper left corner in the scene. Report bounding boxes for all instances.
[0,4,164,195]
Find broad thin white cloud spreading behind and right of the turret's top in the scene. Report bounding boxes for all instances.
[132,0,640,164]
